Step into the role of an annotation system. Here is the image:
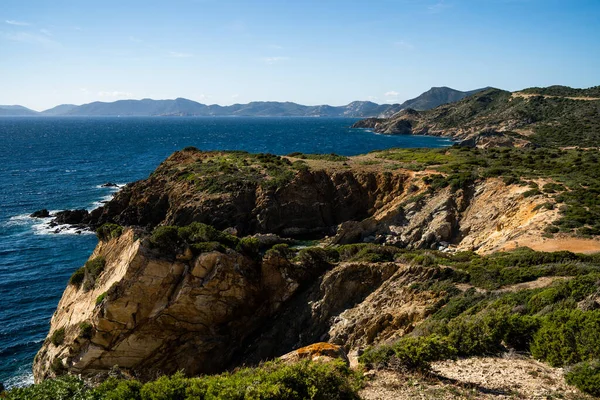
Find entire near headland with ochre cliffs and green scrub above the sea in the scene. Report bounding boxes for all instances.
[9,147,600,399]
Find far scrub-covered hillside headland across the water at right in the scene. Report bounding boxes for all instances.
[355,87,600,147]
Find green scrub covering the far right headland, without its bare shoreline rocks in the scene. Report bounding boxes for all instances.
[386,87,600,147]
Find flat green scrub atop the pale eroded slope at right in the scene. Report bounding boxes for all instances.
[376,147,600,236]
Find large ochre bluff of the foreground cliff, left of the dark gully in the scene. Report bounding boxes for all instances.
[34,230,330,381]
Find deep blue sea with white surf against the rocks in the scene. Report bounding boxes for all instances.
[0,117,451,387]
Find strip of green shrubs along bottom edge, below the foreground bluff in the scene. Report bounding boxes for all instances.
[6,361,361,400]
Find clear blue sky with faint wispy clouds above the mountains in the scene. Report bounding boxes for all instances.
[0,0,600,110]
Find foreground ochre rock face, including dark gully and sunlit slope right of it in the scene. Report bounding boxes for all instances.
[34,230,448,381]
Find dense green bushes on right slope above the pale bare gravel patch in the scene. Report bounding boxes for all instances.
[360,248,600,388]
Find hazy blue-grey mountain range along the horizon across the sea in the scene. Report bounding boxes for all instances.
[0,87,485,118]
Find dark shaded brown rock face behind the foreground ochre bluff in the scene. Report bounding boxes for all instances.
[91,152,406,236]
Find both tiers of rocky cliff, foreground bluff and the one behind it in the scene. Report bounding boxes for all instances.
[34,149,584,381]
